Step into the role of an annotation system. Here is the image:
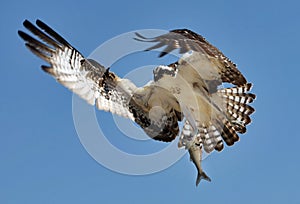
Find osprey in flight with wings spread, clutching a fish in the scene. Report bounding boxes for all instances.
[18,20,255,185]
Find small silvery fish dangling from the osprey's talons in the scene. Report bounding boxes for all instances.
[188,141,211,186]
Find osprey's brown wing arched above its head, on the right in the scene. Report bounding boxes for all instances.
[135,29,247,85]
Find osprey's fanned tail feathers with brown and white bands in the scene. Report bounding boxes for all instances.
[179,83,256,155]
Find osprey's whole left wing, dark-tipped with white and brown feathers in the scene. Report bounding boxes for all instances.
[18,20,179,142]
